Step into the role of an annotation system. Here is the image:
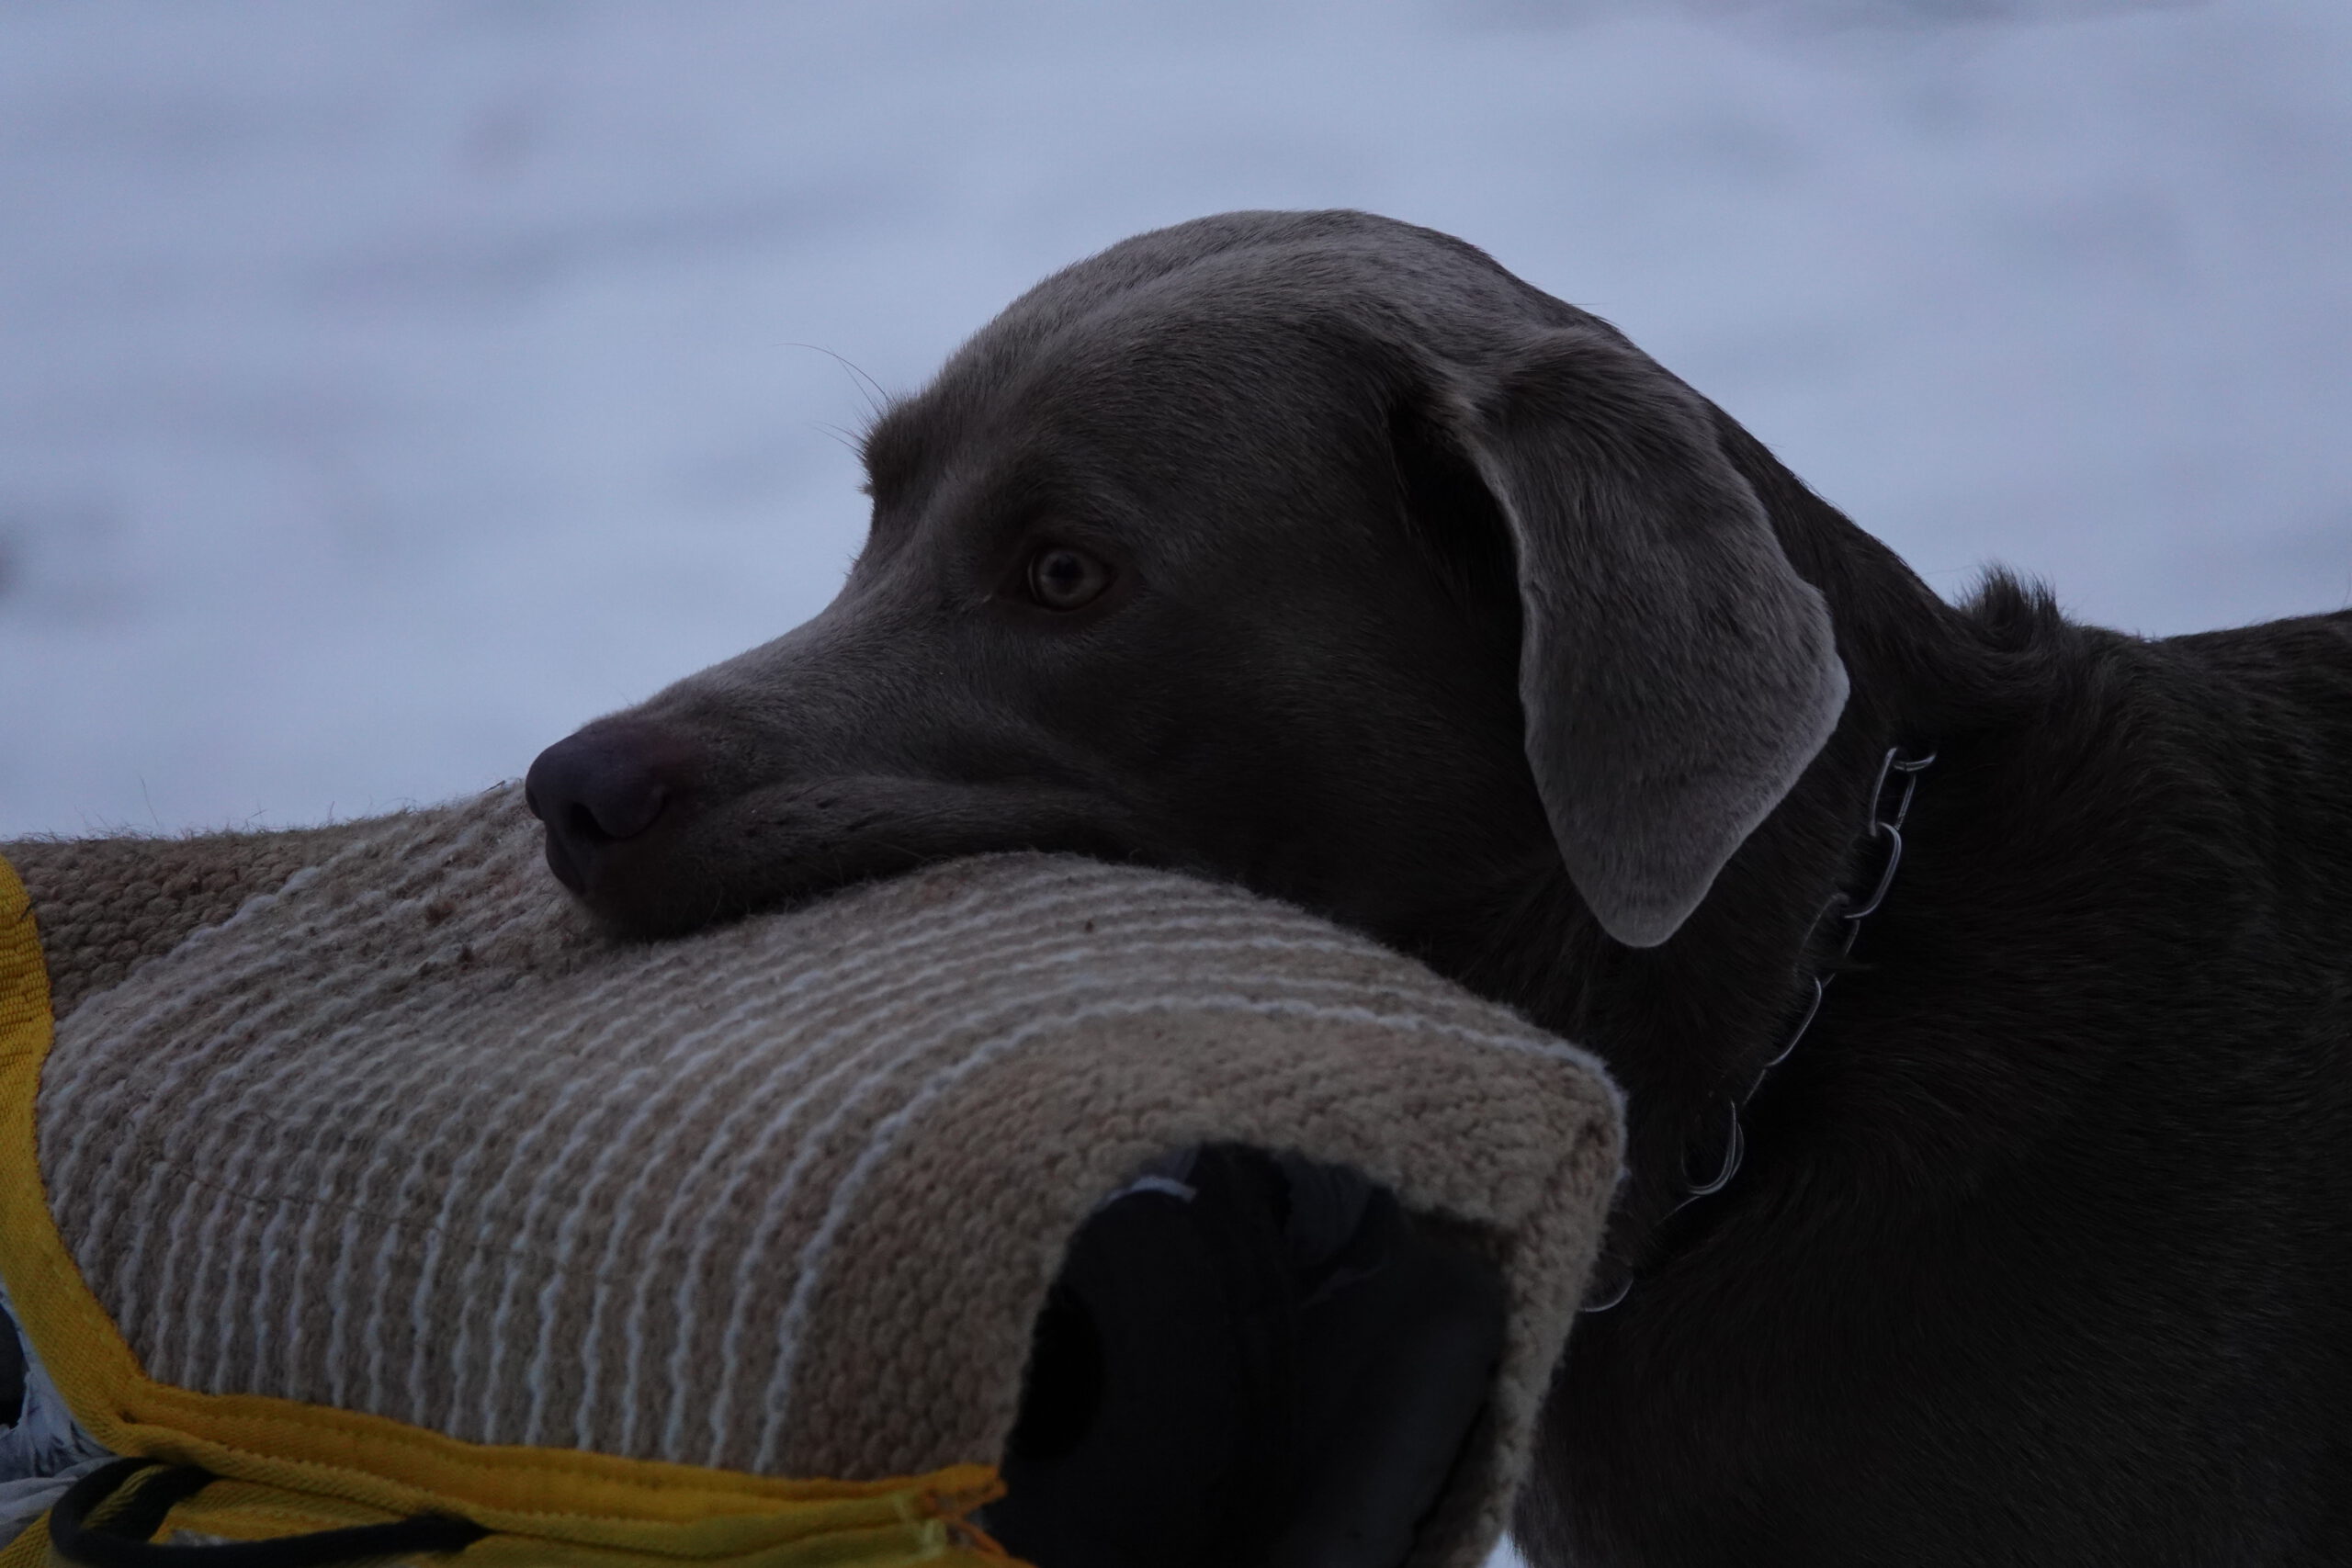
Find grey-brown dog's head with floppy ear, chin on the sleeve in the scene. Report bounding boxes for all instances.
[529,211,1847,945]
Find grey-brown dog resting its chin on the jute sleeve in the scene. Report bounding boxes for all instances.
[526,211,2352,1568]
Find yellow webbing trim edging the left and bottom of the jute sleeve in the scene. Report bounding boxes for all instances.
[0,858,1007,1568]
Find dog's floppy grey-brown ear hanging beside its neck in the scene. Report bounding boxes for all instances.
[1452,327,1847,947]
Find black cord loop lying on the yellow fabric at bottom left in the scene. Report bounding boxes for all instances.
[50,1460,489,1568]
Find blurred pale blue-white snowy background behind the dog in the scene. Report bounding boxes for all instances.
[0,0,2352,837]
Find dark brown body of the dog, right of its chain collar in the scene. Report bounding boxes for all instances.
[1521,592,2352,1568]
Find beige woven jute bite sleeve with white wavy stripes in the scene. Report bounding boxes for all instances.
[9,790,1621,1561]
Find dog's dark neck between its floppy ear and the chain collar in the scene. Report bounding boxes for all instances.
[1463,421,1981,1300]
